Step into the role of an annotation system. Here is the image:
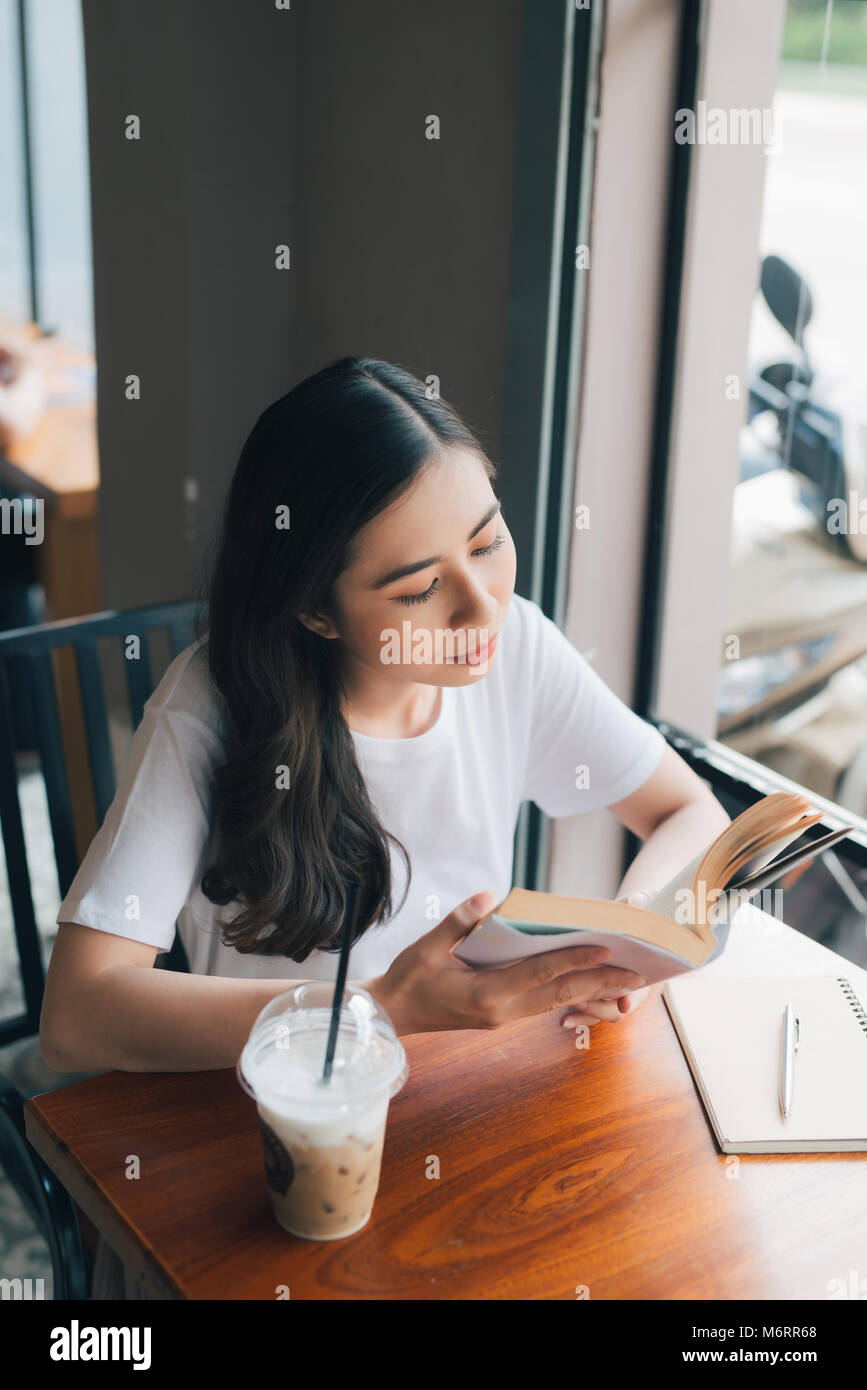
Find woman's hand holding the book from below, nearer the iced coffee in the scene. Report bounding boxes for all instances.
[371,891,645,1036]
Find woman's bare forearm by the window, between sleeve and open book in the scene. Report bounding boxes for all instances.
[611,748,731,897]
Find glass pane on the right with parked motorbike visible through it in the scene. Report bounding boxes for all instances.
[717,0,867,834]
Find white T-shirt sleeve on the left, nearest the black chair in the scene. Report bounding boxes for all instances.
[57,705,220,951]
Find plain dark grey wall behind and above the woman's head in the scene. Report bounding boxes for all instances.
[83,0,522,607]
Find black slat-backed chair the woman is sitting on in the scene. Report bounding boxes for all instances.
[0,600,199,1298]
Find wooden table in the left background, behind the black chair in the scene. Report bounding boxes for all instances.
[0,316,103,859]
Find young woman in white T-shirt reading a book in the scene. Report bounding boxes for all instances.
[40,357,728,1289]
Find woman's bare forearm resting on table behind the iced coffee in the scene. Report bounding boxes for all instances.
[39,922,383,1072]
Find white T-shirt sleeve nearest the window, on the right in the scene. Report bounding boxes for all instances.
[524,605,666,816]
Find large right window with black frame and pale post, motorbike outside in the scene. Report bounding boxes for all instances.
[639,0,867,966]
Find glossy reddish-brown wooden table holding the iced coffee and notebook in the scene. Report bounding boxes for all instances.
[26,906,867,1300]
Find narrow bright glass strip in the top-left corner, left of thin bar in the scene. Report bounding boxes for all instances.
[0,0,31,320]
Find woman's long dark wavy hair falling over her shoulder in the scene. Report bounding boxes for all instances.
[201,357,496,960]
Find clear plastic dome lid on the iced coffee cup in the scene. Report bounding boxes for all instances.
[235,980,410,1111]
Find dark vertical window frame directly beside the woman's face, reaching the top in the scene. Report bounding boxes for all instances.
[502,0,604,888]
